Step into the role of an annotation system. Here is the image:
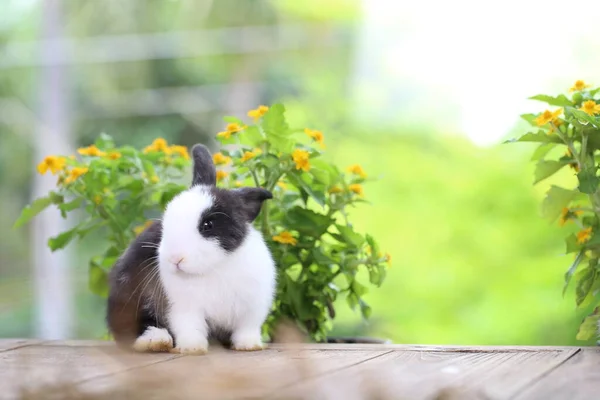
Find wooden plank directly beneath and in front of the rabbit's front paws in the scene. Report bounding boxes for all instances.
[80,348,386,399]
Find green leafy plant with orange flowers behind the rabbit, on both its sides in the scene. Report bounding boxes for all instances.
[15,104,390,341]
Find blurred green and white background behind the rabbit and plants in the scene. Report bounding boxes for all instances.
[0,0,600,345]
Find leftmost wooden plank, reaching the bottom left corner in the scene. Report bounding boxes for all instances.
[0,344,178,398]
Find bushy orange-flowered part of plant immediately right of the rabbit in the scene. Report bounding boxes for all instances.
[213,104,391,340]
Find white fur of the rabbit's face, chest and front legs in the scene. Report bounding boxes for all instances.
[158,186,276,353]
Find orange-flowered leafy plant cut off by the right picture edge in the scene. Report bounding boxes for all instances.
[508,80,600,340]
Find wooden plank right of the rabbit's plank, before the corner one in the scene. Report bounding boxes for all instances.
[270,348,578,399]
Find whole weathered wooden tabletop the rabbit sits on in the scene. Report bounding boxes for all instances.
[0,340,600,400]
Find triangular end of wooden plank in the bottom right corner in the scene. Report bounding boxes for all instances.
[515,347,600,400]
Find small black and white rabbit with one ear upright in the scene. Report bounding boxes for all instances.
[107,144,277,354]
